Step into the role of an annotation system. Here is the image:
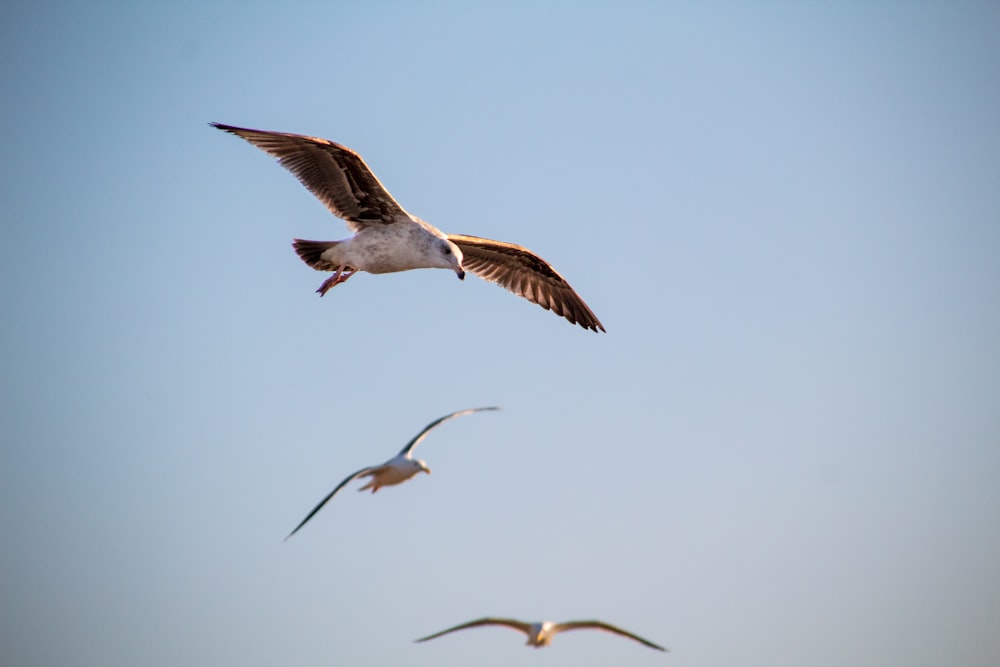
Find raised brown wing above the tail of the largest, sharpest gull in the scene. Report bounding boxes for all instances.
[212,123,413,232]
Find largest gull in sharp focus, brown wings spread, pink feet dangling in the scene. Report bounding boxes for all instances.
[212,123,604,331]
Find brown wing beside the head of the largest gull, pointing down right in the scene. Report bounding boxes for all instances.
[448,234,604,331]
